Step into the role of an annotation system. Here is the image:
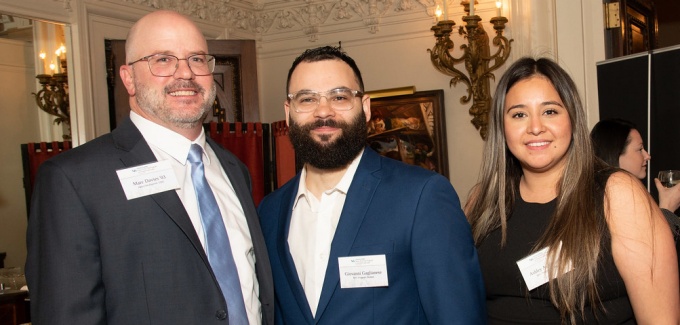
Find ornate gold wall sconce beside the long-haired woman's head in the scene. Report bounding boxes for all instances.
[427,0,513,140]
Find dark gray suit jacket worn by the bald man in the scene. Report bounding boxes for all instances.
[26,119,274,325]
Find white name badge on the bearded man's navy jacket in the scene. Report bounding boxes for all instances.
[338,254,388,289]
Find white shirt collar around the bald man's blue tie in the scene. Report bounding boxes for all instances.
[130,111,210,165]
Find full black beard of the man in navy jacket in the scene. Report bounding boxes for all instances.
[288,111,367,169]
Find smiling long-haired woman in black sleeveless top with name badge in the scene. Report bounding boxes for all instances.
[465,58,680,324]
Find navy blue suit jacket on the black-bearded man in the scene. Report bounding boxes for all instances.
[258,148,486,325]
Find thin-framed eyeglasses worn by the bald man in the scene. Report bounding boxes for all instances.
[128,53,215,77]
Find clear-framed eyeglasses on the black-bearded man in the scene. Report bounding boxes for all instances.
[288,88,364,113]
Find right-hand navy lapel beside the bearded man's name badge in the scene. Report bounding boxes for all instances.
[316,148,380,322]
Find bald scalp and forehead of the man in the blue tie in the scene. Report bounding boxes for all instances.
[125,10,208,62]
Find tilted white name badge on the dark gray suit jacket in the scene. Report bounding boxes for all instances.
[116,160,179,200]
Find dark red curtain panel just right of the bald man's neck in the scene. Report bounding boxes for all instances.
[210,122,265,206]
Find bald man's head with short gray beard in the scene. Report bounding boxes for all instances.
[119,10,215,140]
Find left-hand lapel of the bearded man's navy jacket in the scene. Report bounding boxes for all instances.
[276,177,314,324]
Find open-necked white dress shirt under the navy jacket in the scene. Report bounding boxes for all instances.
[288,150,363,315]
